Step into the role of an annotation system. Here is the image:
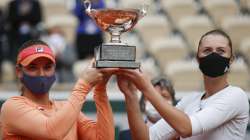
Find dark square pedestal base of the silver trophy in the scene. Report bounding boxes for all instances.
[95,43,140,69]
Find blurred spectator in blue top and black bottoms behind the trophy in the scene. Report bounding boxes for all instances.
[74,0,105,59]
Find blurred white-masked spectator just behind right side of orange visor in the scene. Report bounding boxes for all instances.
[43,25,76,83]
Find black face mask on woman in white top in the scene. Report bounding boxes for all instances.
[198,53,230,77]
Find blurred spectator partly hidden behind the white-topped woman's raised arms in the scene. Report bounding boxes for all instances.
[119,76,176,140]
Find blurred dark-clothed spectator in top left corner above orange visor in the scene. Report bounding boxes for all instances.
[7,0,42,62]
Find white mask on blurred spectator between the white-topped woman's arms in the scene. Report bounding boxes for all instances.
[145,101,161,120]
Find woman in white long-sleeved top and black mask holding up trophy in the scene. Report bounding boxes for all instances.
[118,29,249,140]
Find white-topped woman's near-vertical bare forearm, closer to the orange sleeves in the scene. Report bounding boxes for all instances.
[125,95,149,140]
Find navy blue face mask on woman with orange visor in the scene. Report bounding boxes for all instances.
[21,73,56,94]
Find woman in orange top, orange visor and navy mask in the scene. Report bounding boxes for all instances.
[0,40,115,140]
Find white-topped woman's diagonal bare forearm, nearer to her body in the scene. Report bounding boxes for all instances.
[143,87,192,137]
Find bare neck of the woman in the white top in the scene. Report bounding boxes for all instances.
[203,75,228,99]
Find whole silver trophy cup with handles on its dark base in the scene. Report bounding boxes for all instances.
[84,0,147,68]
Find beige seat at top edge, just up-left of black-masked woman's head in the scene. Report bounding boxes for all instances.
[161,0,197,24]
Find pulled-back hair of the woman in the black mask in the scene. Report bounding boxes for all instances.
[197,29,233,56]
